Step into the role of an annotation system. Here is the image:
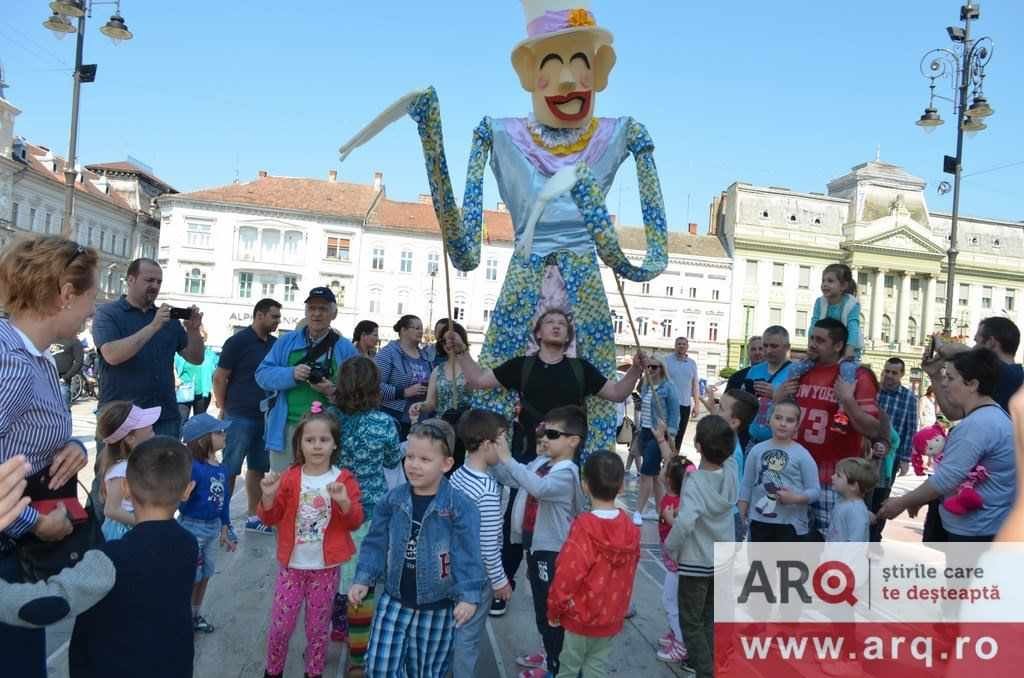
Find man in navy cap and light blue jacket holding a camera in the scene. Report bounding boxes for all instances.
[256,287,357,472]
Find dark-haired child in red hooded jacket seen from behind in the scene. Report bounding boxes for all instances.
[548,452,640,678]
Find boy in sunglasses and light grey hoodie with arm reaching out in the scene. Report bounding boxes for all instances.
[492,405,587,678]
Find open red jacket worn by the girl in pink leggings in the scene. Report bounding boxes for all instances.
[258,466,362,567]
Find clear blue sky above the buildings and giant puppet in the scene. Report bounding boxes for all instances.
[0,0,1024,231]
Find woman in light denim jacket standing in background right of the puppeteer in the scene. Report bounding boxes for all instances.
[633,356,679,525]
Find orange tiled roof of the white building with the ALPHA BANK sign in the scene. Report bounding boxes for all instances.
[167,176,376,221]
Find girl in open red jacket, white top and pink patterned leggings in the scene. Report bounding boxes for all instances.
[259,402,362,678]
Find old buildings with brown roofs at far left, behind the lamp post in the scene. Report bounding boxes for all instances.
[0,94,174,299]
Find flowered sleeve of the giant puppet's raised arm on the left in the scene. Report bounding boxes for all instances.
[409,87,493,270]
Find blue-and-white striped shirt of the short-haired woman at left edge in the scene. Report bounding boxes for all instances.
[0,321,85,537]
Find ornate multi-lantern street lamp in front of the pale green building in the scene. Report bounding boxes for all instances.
[916,0,993,334]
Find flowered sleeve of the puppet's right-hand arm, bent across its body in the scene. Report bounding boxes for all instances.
[571,119,669,283]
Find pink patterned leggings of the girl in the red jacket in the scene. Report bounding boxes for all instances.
[266,567,338,676]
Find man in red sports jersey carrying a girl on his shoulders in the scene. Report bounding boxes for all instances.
[775,317,880,535]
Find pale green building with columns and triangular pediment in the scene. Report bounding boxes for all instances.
[711,160,1024,379]
